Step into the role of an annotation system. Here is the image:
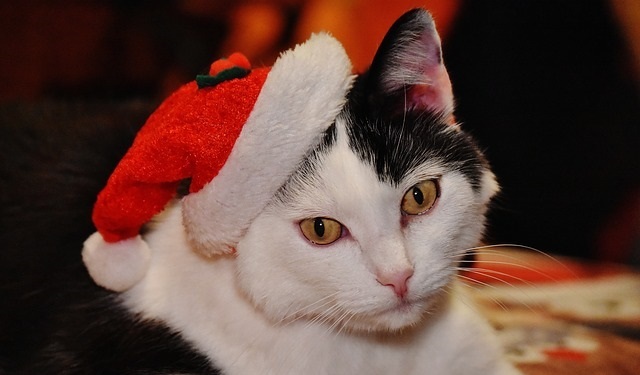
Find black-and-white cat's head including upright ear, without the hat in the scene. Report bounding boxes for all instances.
[237,10,498,331]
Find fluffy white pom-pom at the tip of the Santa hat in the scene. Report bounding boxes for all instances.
[82,232,151,292]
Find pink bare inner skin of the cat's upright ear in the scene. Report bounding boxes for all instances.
[407,64,455,123]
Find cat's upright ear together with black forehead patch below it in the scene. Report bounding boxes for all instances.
[343,9,486,190]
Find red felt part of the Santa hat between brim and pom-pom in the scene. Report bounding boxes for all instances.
[93,68,269,242]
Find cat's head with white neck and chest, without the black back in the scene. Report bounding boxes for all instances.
[122,11,517,374]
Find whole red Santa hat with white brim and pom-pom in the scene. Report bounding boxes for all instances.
[82,34,353,291]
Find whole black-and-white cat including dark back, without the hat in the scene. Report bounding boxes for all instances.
[0,9,519,375]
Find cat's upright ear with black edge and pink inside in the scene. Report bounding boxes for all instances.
[365,9,454,121]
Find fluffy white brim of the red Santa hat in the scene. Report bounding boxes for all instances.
[183,34,353,255]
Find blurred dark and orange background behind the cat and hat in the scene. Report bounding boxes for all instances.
[0,0,640,264]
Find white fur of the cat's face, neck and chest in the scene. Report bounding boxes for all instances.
[121,119,517,375]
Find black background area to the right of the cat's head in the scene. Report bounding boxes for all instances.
[445,0,640,262]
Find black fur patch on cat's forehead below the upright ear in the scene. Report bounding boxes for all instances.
[343,76,487,189]
